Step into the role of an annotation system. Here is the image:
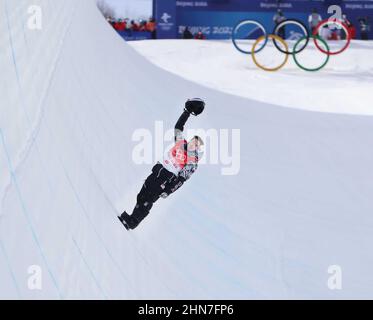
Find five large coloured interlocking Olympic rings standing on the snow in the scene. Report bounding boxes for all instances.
[232,18,351,72]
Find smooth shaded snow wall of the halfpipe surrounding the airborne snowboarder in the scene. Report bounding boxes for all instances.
[0,0,373,299]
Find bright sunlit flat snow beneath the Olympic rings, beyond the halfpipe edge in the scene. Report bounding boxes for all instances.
[129,40,373,115]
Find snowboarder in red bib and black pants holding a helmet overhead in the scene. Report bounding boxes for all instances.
[118,98,205,230]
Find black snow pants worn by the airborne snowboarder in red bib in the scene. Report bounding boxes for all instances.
[132,163,175,226]
